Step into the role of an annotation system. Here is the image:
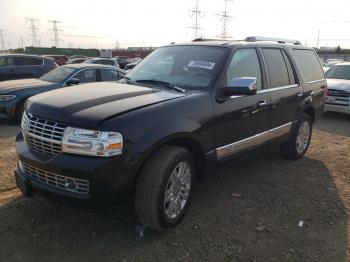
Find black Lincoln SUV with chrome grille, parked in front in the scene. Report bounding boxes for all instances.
[16,37,326,231]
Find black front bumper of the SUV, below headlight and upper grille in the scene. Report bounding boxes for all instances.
[15,133,139,208]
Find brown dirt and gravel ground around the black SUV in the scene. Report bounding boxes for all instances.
[0,114,350,262]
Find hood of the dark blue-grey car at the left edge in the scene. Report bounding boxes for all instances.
[0,78,57,94]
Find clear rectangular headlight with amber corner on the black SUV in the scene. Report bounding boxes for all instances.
[62,127,123,157]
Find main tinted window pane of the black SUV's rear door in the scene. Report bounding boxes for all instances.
[262,48,289,88]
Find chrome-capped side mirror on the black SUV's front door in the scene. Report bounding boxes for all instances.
[224,77,258,96]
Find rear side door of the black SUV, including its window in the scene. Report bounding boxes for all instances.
[261,48,302,130]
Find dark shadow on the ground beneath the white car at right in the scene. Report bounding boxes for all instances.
[315,112,350,137]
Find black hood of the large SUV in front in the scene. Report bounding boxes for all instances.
[26,82,186,127]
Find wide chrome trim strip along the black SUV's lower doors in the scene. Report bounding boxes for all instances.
[215,122,292,160]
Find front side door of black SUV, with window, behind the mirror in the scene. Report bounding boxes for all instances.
[214,48,271,160]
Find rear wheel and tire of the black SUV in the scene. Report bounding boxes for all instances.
[280,113,312,160]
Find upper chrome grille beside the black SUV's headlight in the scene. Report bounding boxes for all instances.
[21,113,65,156]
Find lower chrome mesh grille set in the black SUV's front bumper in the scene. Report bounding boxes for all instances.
[18,161,89,195]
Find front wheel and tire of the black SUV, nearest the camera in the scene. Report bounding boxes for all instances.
[135,146,194,232]
